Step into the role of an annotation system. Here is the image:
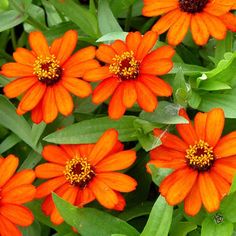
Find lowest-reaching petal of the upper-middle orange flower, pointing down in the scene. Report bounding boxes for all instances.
[108,83,126,120]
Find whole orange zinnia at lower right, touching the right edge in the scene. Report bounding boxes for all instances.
[149,108,236,216]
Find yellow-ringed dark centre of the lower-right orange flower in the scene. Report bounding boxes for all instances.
[185,140,215,171]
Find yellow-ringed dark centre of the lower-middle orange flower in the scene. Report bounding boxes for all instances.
[64,157,95,189]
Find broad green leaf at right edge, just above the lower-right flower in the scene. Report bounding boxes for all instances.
[198,89,236,118]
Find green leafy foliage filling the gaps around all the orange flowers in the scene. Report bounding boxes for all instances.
[0,0,236,236]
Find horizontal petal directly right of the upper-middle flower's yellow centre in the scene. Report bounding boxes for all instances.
[140,59,173,75]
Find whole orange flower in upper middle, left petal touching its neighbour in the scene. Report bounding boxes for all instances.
[84,31,175,119]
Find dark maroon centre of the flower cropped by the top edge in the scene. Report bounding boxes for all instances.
[179,0,209,13]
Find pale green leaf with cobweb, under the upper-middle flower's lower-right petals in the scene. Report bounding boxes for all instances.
[140,101,188,124]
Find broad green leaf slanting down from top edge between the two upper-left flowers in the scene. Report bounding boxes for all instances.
[49,0,98,38]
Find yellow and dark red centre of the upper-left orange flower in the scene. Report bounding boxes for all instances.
[34,55,62,85]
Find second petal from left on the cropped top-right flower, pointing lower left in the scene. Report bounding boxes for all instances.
[152,9,182,34]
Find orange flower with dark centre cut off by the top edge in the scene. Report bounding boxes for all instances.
[143,0,235,45]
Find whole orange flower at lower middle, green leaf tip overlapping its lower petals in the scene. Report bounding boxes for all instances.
[36,129,137,224]
